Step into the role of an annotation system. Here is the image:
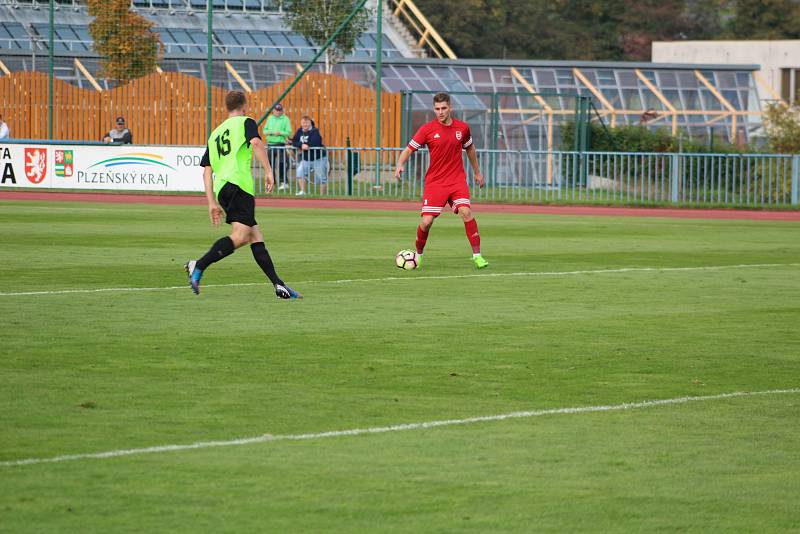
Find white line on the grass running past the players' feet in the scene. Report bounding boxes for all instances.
[0,263,800,297]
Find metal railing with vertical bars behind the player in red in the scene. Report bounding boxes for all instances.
[253,147,800,209]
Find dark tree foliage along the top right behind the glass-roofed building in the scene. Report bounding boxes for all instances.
[415,0,800,61]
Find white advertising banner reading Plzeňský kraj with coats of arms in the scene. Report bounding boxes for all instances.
[0,143,205,191]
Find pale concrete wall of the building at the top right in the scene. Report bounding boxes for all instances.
[652,40,800,100]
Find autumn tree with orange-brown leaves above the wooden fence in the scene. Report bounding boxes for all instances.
[88,0,162,83]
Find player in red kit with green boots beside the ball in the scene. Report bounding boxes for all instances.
[394,93,489,269]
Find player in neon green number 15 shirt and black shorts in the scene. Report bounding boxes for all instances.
[186,91,303,299]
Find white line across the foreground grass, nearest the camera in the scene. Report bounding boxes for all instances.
[0,388,800,467]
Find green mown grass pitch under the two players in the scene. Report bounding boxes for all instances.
[0,201,800,533]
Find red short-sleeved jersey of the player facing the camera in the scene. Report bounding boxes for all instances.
[408,119,472,186]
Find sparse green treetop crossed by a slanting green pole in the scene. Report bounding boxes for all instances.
[283,0,371,73]
